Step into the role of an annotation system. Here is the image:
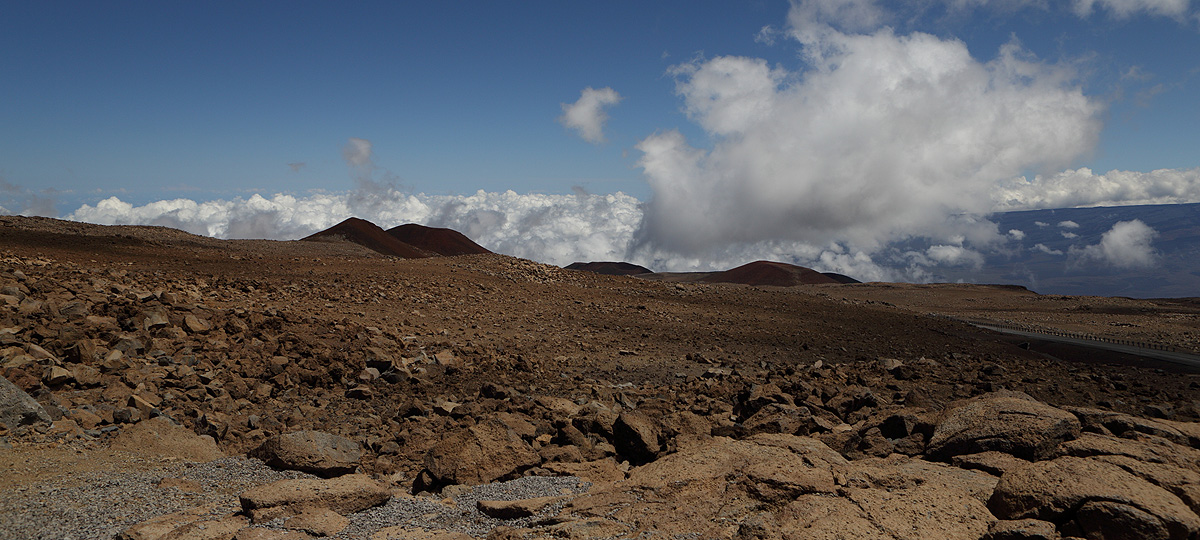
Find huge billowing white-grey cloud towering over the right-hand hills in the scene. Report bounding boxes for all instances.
[637,1,1103,254]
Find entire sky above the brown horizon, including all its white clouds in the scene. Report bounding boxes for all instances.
[0,0,1200,283]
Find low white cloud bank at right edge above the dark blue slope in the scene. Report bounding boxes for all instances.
[991,167,1200,211]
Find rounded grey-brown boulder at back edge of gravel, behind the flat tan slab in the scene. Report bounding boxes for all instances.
[250,430,362,476]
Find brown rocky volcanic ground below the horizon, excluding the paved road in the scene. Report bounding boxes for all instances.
[0,217,1200,540]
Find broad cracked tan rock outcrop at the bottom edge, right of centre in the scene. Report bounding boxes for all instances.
[554,434,996,540]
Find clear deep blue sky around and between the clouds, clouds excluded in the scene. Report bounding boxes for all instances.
[0,1,1200,206]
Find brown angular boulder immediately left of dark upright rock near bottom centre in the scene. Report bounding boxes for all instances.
[425,419,541,485]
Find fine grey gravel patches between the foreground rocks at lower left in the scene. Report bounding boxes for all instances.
[0,457,590,540]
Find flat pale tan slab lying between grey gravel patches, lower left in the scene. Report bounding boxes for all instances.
[240,474,391,523]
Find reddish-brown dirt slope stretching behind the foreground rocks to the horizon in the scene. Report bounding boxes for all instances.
[0,217,1200,475]
